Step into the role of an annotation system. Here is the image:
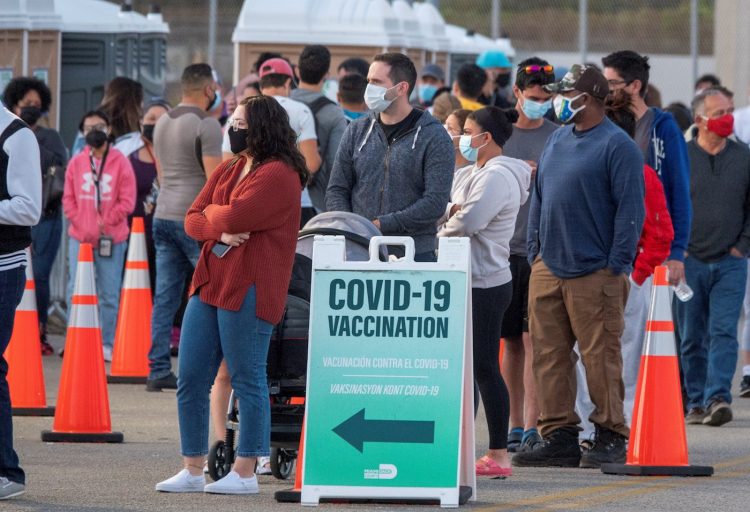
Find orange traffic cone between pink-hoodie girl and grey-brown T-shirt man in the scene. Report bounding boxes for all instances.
[107,217,152,384]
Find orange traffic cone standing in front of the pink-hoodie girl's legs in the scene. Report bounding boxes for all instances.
[42,244,123,443]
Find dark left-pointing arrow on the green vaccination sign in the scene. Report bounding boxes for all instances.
[333,409,435,452]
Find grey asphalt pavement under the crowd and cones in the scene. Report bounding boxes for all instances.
[5,336,750,512]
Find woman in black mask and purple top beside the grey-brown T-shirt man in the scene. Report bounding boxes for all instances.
[115,100,172,293]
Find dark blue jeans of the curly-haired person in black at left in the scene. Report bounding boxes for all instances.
[31,214,62,326]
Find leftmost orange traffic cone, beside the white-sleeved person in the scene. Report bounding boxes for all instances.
[5,249,55,416]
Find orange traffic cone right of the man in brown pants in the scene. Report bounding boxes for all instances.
[602,267,714,476]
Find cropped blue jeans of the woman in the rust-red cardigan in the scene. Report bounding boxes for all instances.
[177,286,273,457]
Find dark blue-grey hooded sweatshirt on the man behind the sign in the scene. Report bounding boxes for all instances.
[326,112,455,253]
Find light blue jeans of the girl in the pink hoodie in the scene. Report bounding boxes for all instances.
[67,238,128,349]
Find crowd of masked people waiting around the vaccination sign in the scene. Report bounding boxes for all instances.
[0,45,750,499]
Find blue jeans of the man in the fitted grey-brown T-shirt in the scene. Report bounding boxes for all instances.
[148,219,201,379]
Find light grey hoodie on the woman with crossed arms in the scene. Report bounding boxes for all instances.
[438,156,531,288]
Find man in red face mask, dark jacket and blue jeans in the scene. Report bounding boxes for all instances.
[675,89,750,426]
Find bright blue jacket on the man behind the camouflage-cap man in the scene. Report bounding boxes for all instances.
[646,108,693,261]
